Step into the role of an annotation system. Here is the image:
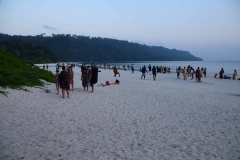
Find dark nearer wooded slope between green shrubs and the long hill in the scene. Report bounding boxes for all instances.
[0,40,59,63]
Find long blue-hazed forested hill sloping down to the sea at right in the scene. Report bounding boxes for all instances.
[0,34,202,62]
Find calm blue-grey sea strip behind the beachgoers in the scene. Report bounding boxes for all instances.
[73,61,240,77]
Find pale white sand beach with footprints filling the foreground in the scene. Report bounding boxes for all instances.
[0,67,240,160]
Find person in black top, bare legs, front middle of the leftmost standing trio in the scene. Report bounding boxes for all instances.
[59,66,70,98]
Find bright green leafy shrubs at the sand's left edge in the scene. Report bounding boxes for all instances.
[0,50,55,91]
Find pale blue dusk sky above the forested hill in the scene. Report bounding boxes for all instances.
[0,0,240,61]
